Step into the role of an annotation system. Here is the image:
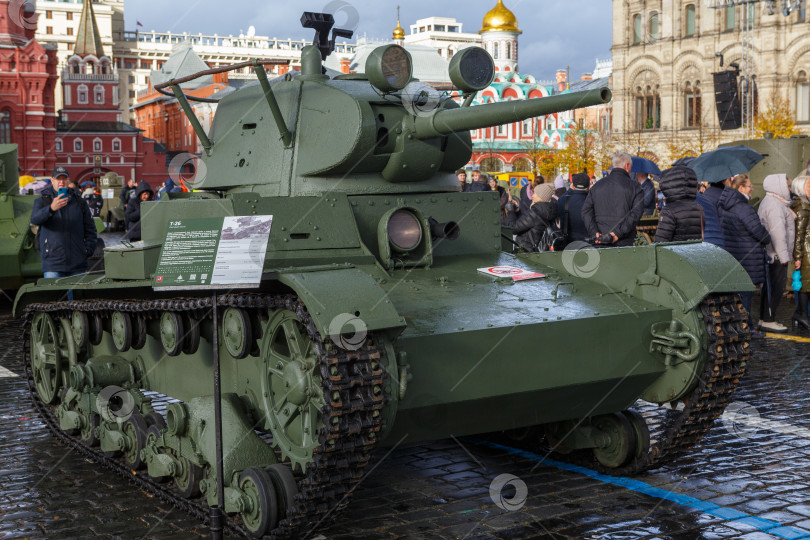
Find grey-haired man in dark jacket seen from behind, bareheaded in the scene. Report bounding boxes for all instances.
[582,152,644,247]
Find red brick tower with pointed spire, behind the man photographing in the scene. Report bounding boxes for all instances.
[54,2,167,186]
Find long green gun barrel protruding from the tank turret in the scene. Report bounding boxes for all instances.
[414,88,611,139]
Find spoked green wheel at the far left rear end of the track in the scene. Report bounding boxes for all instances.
[31,313,63,404]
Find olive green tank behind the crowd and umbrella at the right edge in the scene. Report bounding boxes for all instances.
[720,135,810,204]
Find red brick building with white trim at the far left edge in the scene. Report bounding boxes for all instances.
[0,0,57,176]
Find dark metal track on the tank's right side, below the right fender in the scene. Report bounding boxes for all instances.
[540,295,751,476]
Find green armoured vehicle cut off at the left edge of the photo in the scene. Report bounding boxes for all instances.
[0,144,42,291]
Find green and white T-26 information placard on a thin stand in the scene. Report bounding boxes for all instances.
[152,216,273,289]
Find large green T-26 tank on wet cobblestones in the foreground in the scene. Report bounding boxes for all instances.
[15,13,753,538]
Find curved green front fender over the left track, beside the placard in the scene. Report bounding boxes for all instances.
[278,268,406,339]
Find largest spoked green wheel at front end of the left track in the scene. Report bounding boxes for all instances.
[261,310,325,470]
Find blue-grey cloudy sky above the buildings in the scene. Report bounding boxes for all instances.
[125,0,612,80]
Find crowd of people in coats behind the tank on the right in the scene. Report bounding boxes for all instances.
[458,152,810,337]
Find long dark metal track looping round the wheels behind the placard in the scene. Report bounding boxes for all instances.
[23,294,386,539]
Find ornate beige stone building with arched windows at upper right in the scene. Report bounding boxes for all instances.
[611,0,810,161]
